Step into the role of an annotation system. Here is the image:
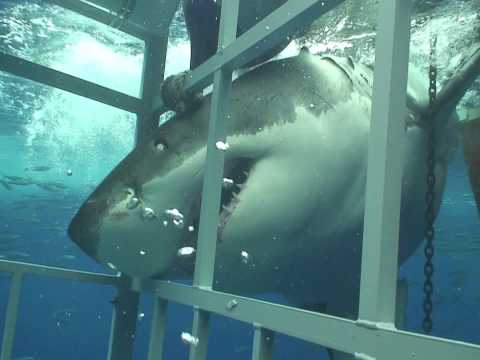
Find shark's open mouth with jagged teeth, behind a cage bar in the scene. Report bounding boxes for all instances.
[189,158,254,241]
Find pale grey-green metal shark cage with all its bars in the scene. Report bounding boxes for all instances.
[0,0,480,360]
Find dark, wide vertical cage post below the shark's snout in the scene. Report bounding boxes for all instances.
[107,289,140,360]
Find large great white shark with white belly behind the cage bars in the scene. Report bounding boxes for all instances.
[68,47,479,358]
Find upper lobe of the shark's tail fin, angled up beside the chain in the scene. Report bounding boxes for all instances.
[433,45,480,115]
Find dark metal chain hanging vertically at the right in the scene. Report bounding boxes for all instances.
[422,36,437,334]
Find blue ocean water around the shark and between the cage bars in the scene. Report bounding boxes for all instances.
[0,0,480,360]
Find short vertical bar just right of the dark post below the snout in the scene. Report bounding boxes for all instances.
[148,298,168,360]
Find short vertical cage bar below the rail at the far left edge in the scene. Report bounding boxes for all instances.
[0,272,23,360]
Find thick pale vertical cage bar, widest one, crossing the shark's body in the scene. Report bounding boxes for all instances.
[359,0,411,324]
